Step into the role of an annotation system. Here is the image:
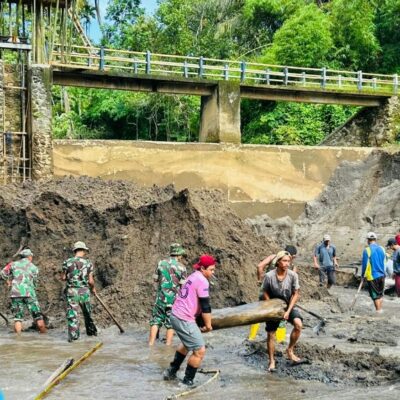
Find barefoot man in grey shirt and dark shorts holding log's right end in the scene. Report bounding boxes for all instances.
[263,251,303,372]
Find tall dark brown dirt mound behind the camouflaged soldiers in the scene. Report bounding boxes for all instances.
[0,177,282,324]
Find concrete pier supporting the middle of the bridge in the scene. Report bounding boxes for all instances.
[199,81,241,143]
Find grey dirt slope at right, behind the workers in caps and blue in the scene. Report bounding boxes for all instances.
[248,151,400,264]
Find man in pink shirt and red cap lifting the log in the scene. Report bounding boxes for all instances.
[164,254,216,386]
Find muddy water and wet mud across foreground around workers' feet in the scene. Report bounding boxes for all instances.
[0,287,400,400]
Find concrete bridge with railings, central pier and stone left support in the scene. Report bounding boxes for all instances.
[0,41,400,183]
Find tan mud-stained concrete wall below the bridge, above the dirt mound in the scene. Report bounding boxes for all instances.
[53,140,373,218]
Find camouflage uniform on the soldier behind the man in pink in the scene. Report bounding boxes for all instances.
[150,257,187,329]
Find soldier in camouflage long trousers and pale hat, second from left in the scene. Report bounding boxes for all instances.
[62,242,97,342]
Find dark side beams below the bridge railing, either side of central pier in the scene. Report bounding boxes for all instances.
[53,67,391,107]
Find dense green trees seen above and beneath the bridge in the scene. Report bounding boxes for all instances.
[54,0,400,145]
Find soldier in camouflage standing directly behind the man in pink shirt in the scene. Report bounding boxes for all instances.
[149,243,187,346]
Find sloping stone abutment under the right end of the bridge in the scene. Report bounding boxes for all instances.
[320,96,400,147]
